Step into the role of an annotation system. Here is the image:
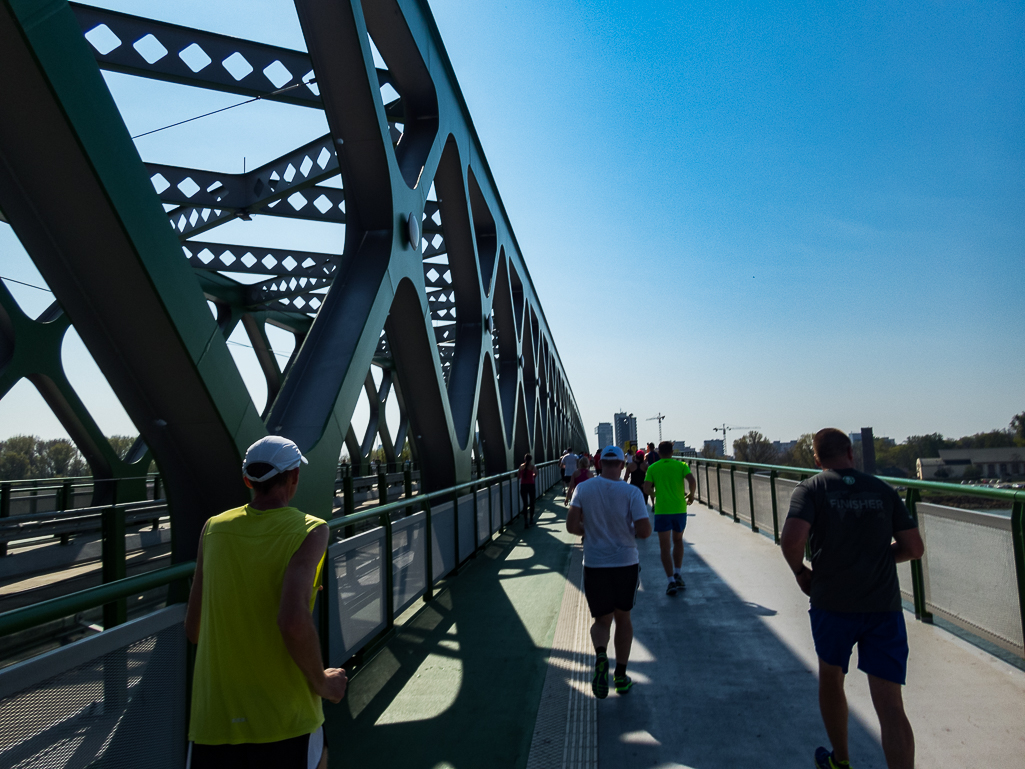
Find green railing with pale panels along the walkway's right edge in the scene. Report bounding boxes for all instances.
[686,457,1025,657]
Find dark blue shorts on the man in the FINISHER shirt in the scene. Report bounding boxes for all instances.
[808,607,907,686]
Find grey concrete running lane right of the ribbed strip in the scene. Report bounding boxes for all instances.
[598,505,1025,769]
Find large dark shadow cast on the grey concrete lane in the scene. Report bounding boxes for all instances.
[599,519,886,769]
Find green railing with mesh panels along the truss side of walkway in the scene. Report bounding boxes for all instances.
[0,461,560,769]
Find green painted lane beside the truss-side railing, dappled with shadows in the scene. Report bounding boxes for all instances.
[324,486,575,769]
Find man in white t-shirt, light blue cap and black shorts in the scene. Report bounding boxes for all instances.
[566,446,651,699]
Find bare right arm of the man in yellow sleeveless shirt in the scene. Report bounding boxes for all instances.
[280,526,347,702]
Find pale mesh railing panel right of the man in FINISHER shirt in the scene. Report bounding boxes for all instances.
[917,502,1025,654]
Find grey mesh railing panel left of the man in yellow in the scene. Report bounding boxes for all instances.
[0,605,186,769]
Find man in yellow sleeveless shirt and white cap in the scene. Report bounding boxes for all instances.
[186,436,346,769]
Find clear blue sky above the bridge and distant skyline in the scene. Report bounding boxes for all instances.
[0,0,1025,455]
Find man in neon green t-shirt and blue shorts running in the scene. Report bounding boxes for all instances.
[644,441,697,596]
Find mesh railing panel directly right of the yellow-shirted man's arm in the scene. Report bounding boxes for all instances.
[325,528,385,664]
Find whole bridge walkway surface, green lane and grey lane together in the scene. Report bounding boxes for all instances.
[326,491,1025,769]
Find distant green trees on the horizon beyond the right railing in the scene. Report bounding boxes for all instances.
[721,411,1025,477]
